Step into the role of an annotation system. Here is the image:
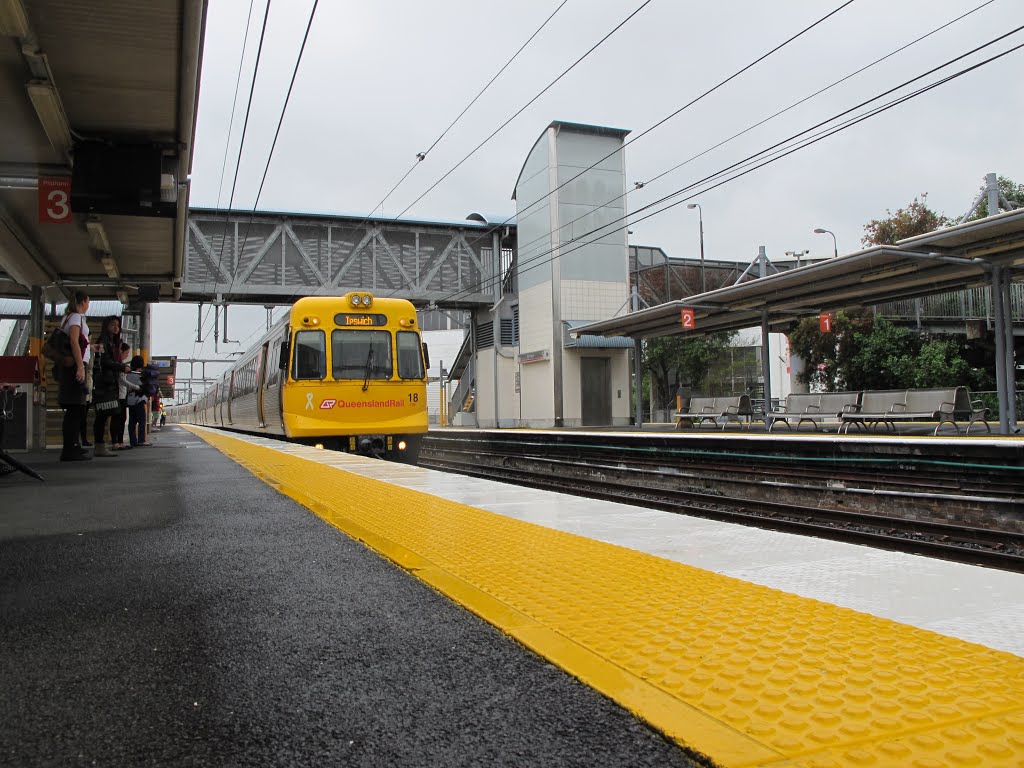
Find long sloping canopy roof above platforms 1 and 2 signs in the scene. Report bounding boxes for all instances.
[572,211,1024,338]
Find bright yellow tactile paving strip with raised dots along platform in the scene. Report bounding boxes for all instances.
[186,429,1024,768]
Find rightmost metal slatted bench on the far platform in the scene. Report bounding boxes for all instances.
[840,387,992,434]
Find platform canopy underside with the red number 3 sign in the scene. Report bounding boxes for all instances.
[0,0,207,301]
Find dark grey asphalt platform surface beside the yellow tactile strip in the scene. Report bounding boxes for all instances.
[0,427,696,768]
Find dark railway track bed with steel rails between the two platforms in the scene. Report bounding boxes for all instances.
[420,442,1024,572]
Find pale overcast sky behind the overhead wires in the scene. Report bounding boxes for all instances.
[153,0,1024,397]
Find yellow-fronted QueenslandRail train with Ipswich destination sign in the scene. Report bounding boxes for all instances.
[180,291,430,462]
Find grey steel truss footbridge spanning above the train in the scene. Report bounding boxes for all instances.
[181,208,515,308]
